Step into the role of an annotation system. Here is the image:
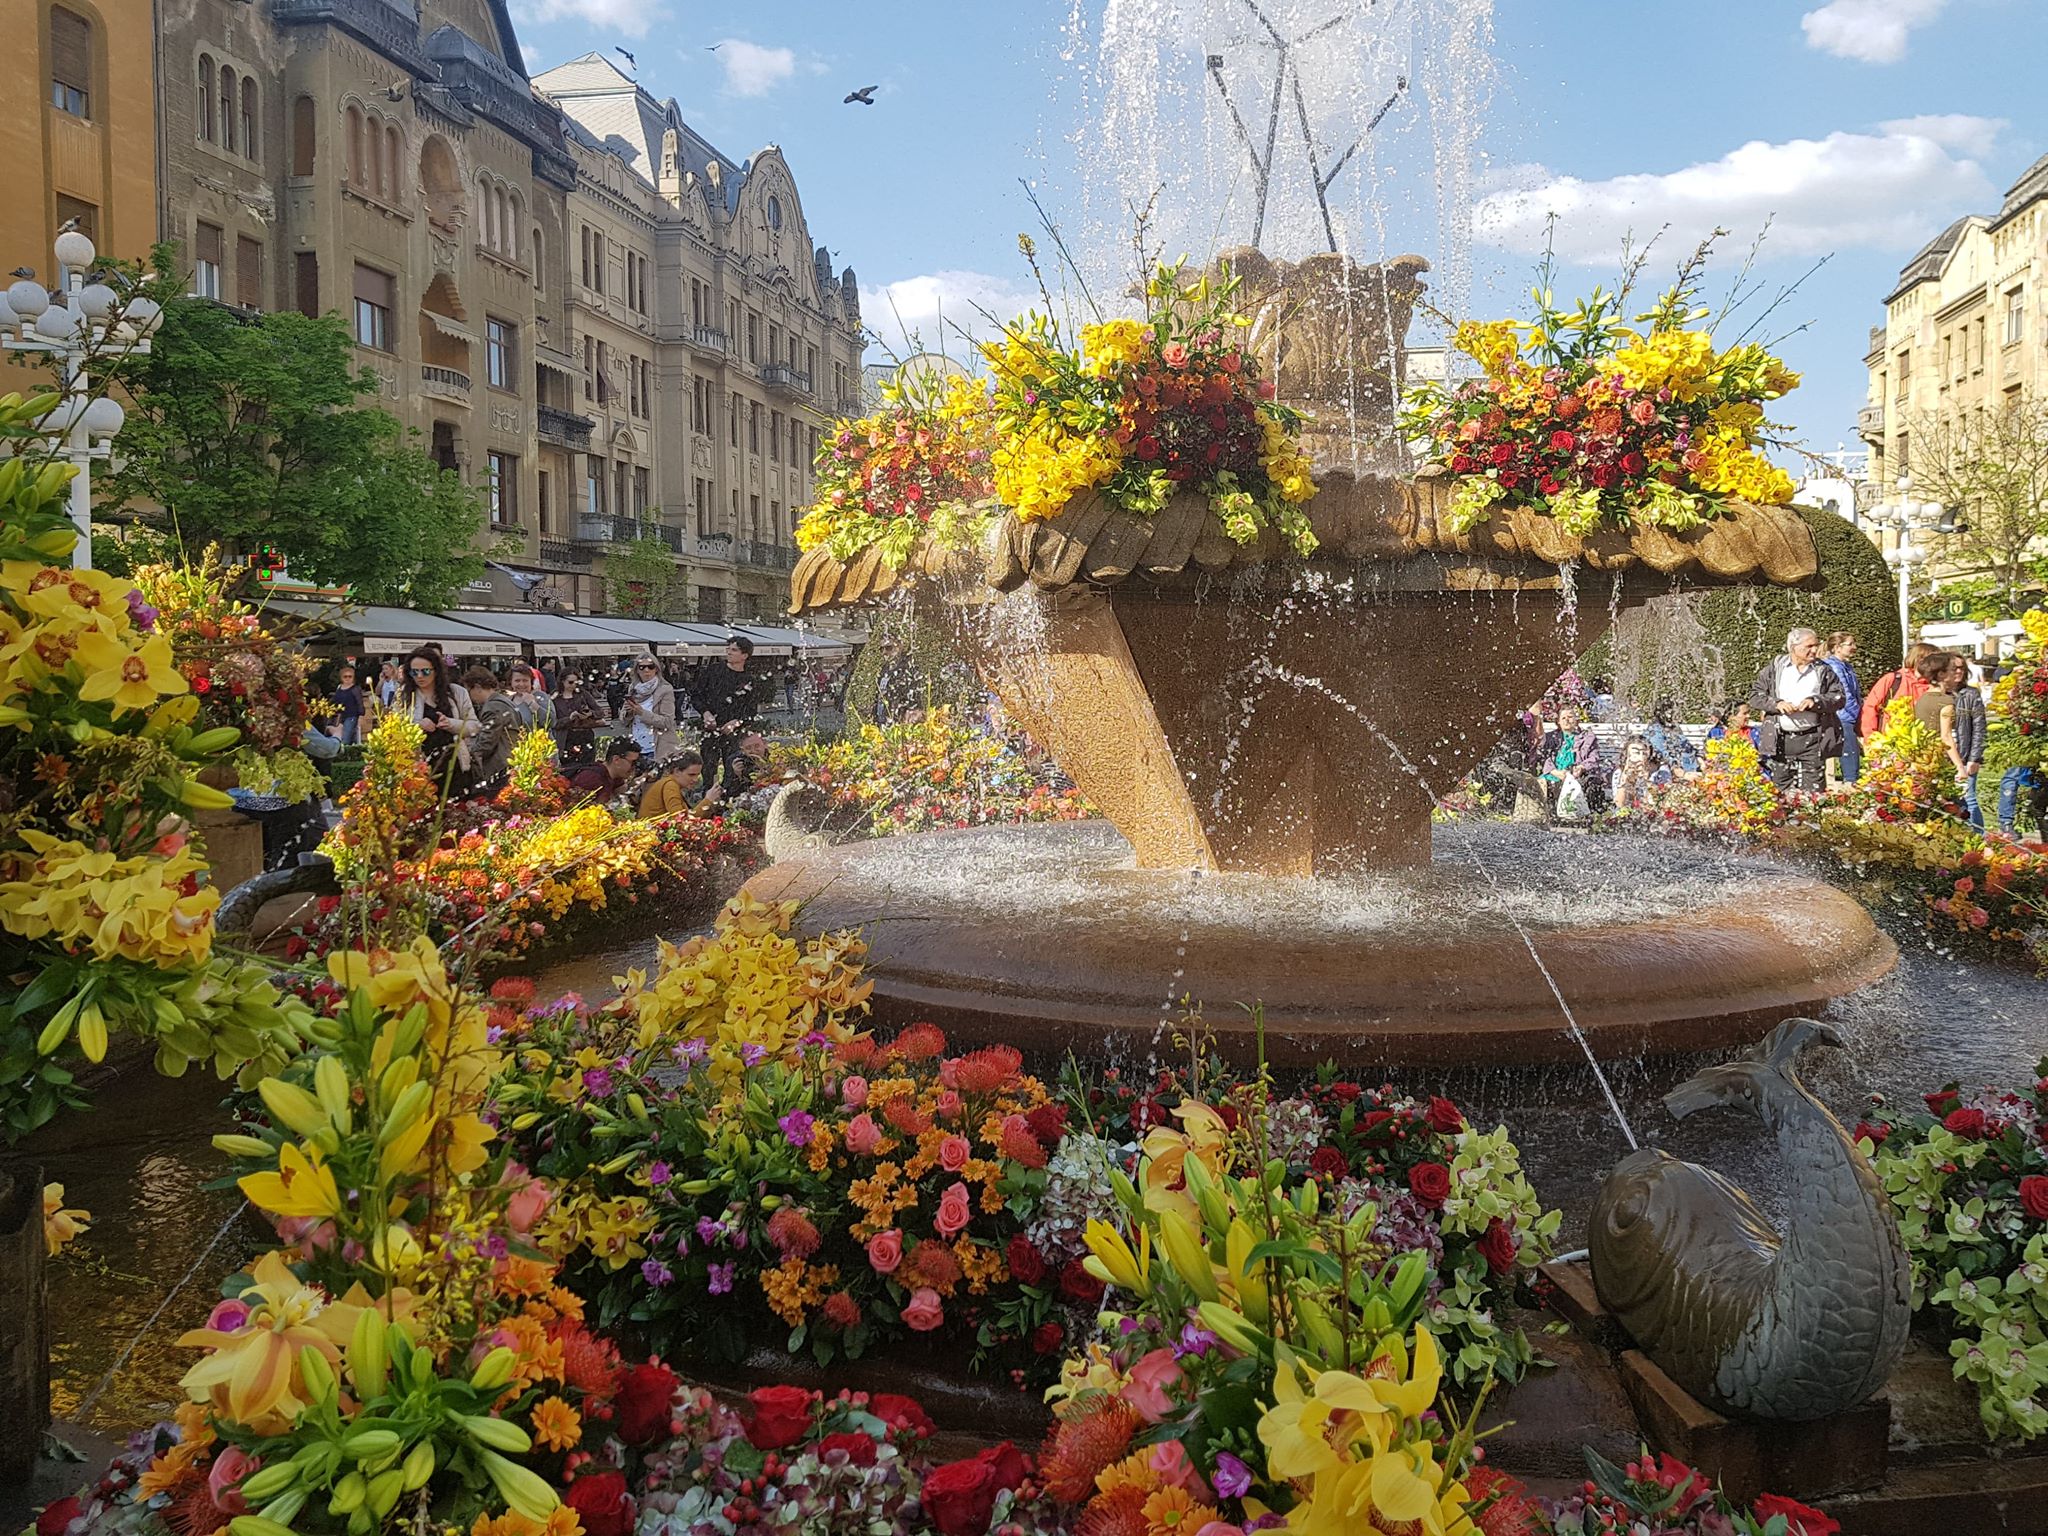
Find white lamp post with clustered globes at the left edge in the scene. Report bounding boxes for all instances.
[0,229,164,567]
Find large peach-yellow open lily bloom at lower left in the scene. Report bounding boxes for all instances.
[178,1253,358,1434]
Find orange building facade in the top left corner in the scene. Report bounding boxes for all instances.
[0,0,156,393]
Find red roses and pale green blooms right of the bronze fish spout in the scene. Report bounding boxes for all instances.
[1855,1061,2048,1442]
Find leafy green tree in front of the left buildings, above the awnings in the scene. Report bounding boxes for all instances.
[94,297,485,608]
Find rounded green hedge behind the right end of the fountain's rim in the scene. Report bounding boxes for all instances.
[1579,506,1903,721]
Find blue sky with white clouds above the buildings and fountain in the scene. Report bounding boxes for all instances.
[512,0,2048,466]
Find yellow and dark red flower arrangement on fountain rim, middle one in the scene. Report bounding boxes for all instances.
[983,264,1315,555]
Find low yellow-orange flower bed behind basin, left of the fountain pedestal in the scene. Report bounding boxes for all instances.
[768,709,1096,838]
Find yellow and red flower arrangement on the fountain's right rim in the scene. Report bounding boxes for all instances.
[1403,266,1798,535]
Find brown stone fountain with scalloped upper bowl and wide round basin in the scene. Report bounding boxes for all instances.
[770,473,1896,1065]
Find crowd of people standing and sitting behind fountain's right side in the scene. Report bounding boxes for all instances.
[1520,629,2048,831]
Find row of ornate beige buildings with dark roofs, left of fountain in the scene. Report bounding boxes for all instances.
[142,0,862,621]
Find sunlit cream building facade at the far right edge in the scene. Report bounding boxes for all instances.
[1855,158,2048,580]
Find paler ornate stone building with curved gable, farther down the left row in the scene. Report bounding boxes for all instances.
[535,53,862,621]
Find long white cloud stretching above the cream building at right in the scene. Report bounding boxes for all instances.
[1473,115,2001,262]
